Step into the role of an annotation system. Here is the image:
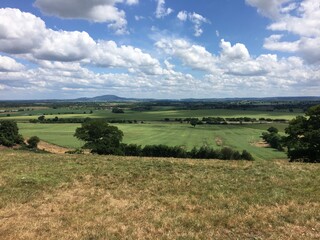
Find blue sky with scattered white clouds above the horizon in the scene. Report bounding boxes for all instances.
[0,0,320,100]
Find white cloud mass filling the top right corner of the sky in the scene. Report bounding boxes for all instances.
[246,0,320,64]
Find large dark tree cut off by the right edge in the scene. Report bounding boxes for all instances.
[285,105,320,162]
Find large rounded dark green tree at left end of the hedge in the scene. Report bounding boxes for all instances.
[74,119,123,155]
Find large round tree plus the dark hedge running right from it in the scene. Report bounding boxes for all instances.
[75,119,253,160]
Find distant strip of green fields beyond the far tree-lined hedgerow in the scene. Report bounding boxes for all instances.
[0,109,301,122]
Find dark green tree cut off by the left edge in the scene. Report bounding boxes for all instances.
[0,120,23,147]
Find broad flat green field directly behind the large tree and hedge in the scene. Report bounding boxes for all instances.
[19,123,286,159]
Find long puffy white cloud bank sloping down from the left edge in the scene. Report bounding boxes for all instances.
[0,9,162,74]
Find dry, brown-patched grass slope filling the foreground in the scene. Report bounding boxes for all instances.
[0,151,320,239]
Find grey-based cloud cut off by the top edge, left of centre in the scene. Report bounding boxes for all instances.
[34,0,139,34]
